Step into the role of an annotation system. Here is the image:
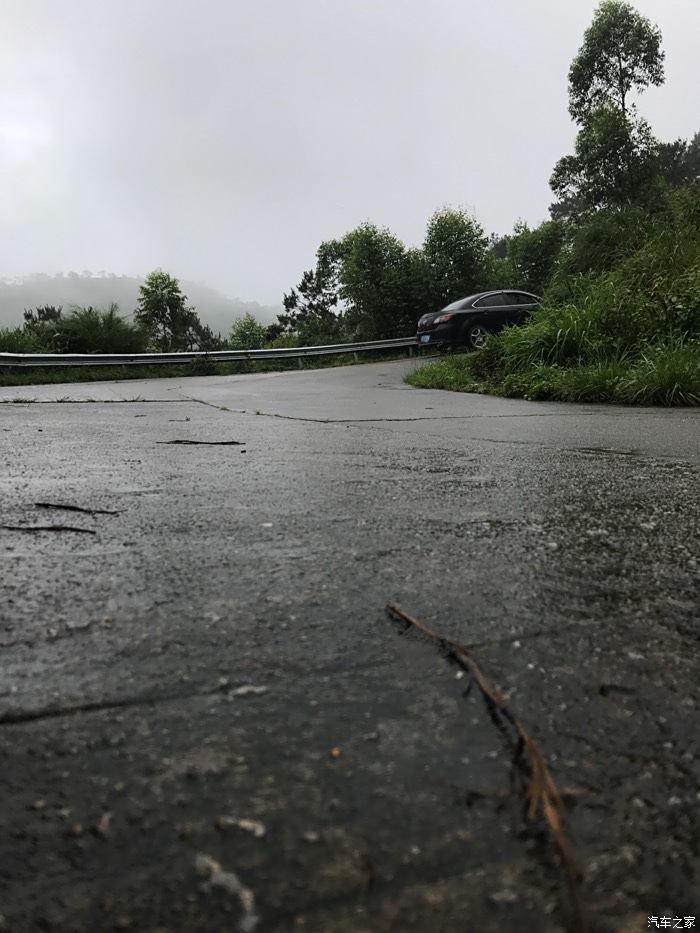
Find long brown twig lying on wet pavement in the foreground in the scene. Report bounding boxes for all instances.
[386,603,588,933]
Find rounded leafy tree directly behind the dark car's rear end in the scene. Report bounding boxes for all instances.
[423,208,488,309]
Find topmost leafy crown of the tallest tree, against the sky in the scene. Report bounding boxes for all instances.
[569,0,664,124]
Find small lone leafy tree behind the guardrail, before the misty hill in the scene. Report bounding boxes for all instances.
[134,269,213,352]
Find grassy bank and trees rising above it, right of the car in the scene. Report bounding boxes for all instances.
[409,0,700,405]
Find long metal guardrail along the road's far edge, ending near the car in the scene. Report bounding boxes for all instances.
[0,337,418,367]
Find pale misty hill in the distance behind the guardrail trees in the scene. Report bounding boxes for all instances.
[0,272,282,334]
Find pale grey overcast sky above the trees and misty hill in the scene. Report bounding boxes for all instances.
[0,0,700,302]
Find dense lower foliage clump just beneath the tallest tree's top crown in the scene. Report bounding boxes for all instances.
[549,104,659,210]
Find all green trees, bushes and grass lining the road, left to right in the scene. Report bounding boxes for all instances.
[0,0,700,405]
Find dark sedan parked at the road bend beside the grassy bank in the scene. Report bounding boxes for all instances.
[417,290,541,350]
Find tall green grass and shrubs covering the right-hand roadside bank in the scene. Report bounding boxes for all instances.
[408,187,700,405]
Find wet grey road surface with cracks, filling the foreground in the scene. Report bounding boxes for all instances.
[0,362,700,933]
